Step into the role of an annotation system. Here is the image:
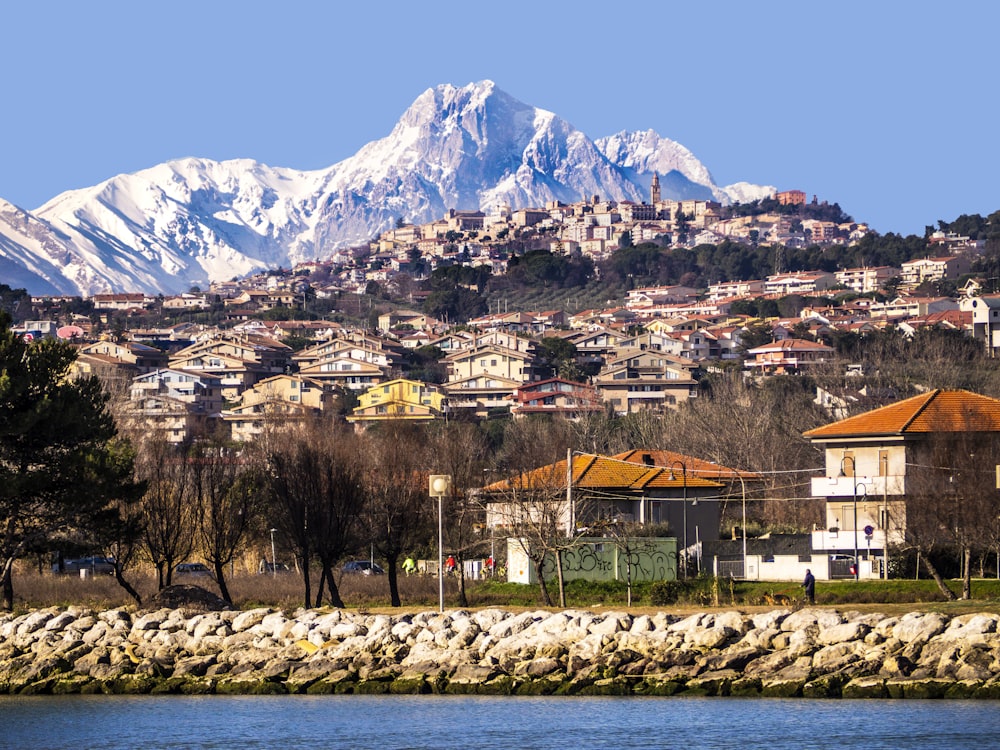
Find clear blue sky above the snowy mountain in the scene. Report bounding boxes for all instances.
[0,0,1000,234]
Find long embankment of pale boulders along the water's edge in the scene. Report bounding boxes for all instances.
[0,608,1000,698]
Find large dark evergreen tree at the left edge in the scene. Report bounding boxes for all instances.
[0,312,136,610]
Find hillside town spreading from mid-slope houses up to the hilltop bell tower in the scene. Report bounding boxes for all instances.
[5,177,1000,443]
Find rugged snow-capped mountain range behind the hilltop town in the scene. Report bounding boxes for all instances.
[0,81,774,295]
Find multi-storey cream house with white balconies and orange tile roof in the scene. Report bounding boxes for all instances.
[804,389,1000,578]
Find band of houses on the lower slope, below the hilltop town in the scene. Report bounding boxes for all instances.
[11,256,1000,452]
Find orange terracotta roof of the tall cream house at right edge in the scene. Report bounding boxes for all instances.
[803,389,1000,439]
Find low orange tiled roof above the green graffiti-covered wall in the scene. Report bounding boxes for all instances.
[483,455,722,492]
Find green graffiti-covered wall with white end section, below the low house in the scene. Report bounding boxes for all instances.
[507,537,677,583]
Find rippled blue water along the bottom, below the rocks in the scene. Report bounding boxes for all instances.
[0,696,1000,750]
